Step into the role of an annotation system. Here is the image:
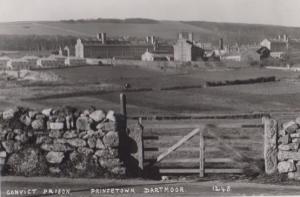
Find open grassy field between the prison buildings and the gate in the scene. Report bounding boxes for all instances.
[15,66,300,117]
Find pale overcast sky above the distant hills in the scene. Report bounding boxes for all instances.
[0,0,300,27]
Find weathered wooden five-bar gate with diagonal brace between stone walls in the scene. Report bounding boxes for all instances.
[127,118,264,177]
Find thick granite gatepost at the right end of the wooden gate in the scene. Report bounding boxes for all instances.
[262,117,278,174]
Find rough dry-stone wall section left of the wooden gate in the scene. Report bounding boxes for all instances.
[0,107,126,177]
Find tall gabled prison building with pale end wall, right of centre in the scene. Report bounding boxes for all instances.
[174,33,204,62]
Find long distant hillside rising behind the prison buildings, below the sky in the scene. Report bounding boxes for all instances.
[0,18,300,50]
